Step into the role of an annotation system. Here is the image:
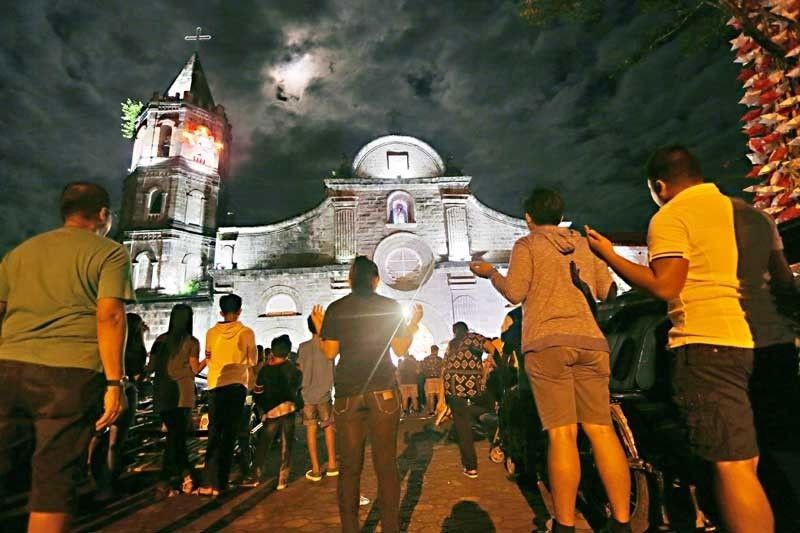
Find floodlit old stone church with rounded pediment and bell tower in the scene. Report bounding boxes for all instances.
[122,54,642,357]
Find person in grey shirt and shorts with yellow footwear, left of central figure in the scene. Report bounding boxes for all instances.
[297,317,339,482]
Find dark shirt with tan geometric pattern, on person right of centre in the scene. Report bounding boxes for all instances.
[444,332,487,399]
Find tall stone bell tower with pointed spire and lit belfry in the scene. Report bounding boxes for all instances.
[121,52,231,299]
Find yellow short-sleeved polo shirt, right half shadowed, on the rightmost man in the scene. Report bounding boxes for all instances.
[647,183,792,348]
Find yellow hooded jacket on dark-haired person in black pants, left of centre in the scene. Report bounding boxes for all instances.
[206,321,257,389]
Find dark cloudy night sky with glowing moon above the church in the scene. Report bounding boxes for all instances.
[0,0,748,254]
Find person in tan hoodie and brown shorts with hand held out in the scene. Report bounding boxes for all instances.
[470,189,630,532]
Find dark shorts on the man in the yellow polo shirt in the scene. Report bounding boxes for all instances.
[672,344,758,462]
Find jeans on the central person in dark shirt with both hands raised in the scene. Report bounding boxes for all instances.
[333,389,400,533]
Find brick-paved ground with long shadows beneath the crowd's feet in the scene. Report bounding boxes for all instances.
[86,419,568,533]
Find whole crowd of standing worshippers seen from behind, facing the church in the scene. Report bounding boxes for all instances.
[0,146,798,532]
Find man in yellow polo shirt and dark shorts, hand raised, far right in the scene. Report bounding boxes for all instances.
[586,146,797,532]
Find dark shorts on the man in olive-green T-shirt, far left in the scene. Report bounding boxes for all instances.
[0,360,105,513]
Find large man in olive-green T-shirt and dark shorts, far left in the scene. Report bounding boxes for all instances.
[0,182,135,532]
